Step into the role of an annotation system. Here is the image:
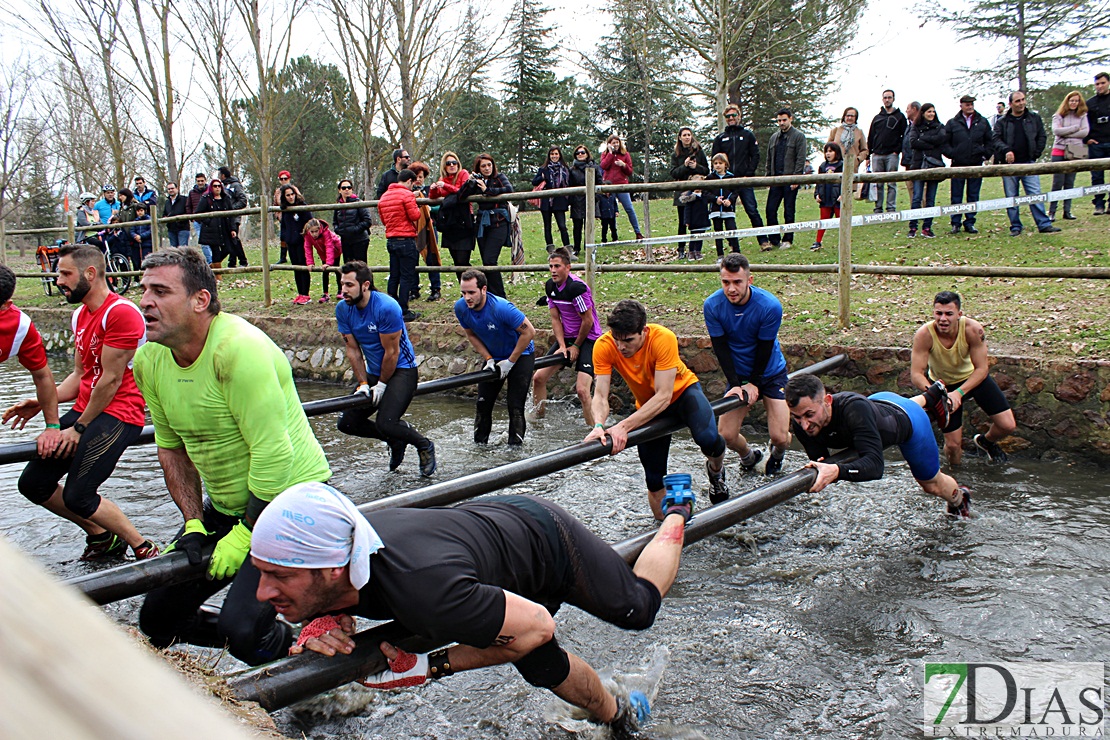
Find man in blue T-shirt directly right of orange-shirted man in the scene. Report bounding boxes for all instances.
[703,252,790,504]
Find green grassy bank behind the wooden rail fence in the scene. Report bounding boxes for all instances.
[9,176,1110,358]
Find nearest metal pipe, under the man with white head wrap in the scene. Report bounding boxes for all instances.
[228,454,854,711]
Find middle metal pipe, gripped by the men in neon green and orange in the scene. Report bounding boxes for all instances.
[64,354,848,605]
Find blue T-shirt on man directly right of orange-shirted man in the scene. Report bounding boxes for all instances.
[703,285,786,378]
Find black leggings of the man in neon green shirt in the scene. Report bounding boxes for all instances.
[139,499,293,666]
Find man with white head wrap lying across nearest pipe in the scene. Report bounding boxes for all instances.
[251,484,694,738]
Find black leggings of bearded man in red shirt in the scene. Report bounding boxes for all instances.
[19,409,142,519]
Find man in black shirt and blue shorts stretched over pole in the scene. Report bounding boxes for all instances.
[786,375,971,517]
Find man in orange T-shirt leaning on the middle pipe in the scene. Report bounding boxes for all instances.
[586,300,725,521]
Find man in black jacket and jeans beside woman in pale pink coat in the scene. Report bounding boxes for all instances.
[993,90,1060,236]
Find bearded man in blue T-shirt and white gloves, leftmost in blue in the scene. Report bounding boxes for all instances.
[335,261,435,476]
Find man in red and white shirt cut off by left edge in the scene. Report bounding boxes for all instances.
[0,265,62,456]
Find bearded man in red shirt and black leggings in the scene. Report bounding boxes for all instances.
[4,244,158,560]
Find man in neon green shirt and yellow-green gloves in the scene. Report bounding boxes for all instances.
[134,247,331,666]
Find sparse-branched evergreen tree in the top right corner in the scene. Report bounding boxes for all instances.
[922,0,1110,90]
